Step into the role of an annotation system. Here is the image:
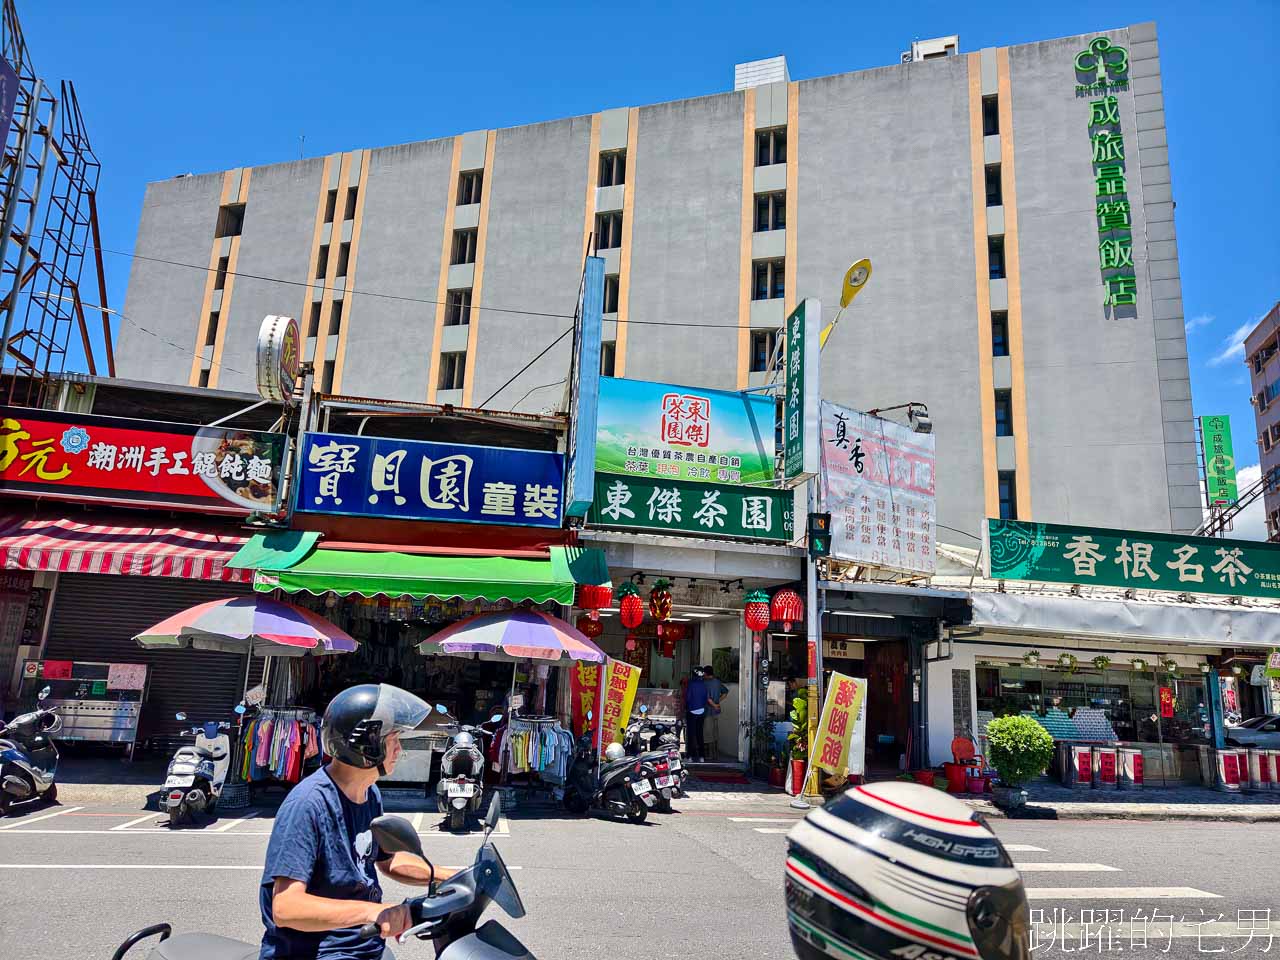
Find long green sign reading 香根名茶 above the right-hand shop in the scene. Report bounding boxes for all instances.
[987,520,1280,599]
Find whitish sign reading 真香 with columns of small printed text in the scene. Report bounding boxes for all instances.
[819,401,936,573]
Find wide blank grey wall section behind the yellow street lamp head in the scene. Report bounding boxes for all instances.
[787,56,984,535]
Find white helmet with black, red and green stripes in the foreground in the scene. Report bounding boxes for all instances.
[786,782,1030,960]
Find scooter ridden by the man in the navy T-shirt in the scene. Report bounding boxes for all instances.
[111,797,535,960]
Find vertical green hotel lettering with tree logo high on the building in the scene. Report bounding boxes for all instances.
[1075,37,1138,308]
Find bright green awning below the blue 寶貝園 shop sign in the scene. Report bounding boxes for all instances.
[237,544,609,604]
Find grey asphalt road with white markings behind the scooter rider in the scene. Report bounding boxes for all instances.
[0,797,1280,960]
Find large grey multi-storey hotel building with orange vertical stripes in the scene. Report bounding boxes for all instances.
[118,23,1201,534]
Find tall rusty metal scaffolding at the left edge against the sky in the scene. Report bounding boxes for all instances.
[0,0,115,406]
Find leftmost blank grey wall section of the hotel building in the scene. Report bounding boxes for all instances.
[115,173,223,384]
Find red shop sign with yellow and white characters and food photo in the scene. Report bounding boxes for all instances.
[0,407,285,513]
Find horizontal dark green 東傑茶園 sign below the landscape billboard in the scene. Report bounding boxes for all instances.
[588,474,794,543]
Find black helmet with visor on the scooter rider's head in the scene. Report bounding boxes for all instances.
[321,684,431,776]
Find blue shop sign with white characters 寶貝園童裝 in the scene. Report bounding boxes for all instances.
[294,434,564,527]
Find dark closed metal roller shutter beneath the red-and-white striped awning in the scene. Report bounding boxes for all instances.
[45,573,252,742]
